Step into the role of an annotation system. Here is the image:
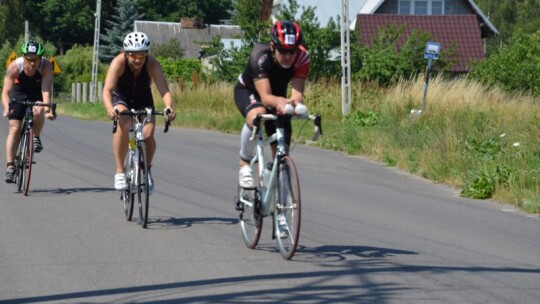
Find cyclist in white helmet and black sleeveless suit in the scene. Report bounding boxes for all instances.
[102,32,176,193]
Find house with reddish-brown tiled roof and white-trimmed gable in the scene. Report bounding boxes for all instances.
[351,0,499,73]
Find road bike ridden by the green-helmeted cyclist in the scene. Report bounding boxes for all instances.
[12,100,56,196]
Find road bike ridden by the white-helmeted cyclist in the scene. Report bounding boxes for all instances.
[113,108,171,228]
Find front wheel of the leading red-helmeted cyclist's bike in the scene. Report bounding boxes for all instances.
[274,156,302,260]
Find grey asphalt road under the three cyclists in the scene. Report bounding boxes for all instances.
[0,117,540,303]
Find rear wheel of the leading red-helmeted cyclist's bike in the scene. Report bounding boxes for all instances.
[238,162,263,249]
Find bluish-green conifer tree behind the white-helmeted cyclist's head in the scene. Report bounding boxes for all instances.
[99,0,144,63]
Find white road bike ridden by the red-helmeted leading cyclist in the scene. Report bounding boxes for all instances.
[235,106,322,260]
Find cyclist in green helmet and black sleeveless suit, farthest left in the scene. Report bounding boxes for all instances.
[2,40,55,183]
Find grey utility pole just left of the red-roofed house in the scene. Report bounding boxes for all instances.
[341,0,352,116]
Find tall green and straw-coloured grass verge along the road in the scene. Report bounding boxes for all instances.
[58,77,540,213]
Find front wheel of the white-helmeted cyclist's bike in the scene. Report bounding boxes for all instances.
[137,141,150,228]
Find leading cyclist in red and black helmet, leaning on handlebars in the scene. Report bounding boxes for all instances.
[234,20,311,188]
